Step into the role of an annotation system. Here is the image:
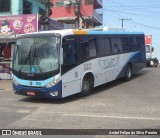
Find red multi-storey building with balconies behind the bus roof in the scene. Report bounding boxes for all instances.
[50,0,102,28]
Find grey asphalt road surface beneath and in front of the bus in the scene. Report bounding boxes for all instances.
[0,68,160,137]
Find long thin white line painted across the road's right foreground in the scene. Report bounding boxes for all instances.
[63,114,160,121]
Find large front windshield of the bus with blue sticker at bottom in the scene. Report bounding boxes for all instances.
[13,36,60,74]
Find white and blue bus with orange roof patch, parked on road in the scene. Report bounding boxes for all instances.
[12,29,146,98]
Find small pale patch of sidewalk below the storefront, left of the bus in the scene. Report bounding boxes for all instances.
[0,80,12,90]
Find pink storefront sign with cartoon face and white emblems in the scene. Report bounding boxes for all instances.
[0,14,38,37]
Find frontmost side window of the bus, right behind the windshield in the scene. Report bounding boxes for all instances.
[62,39,77,65]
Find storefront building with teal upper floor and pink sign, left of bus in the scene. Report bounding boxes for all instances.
[0,0,45,79]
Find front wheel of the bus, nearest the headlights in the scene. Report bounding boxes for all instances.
[79,75,94,96]
